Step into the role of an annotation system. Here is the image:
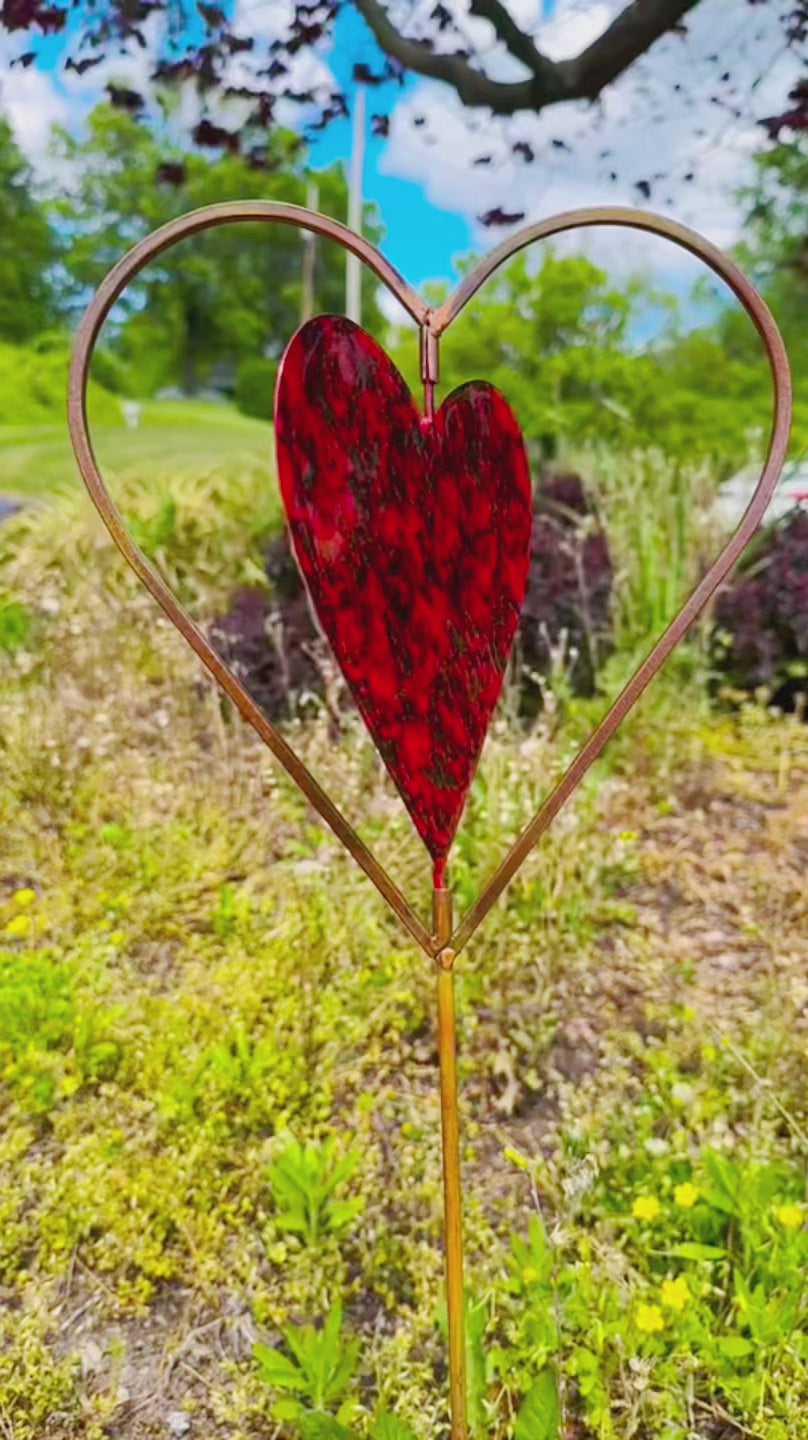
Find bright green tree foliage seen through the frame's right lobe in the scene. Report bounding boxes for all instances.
[398,252,769,472]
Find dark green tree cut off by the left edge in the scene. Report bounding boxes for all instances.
[0,118,58,344]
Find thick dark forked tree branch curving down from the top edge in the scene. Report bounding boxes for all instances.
[353,0,699,115]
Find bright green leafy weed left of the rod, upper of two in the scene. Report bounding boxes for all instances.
[266,1138,364,1246]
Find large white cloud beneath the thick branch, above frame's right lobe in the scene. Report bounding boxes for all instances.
[382,0,798,288]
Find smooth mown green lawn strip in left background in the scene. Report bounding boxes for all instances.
[0,400,272,497]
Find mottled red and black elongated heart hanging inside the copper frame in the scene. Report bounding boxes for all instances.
[275,315,531,863]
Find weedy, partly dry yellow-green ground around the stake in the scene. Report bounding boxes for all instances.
[0,440,808,1440]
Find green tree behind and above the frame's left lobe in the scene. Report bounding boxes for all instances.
[55,105,380,395]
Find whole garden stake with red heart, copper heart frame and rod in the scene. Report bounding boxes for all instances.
[69,202,791,1440]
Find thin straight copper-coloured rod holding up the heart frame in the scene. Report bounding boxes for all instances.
[432,887,468,1440]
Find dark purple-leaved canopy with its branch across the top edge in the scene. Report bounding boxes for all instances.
[0,0,808,185]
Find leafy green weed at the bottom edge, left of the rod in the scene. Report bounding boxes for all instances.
[255,1305,360,1440]
